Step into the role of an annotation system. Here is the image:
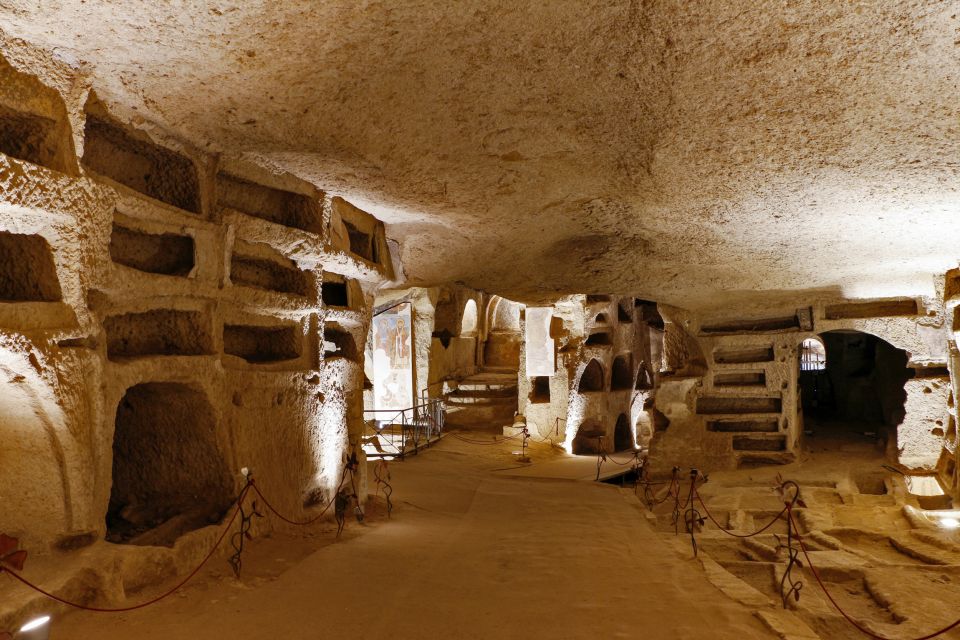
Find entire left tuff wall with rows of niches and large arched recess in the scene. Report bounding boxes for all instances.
[0,38,393,627]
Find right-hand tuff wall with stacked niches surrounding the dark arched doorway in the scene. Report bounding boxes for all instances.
[651,285,952,473]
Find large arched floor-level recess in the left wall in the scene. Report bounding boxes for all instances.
[107,382,234,546]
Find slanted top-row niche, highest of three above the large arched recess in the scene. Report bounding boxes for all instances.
[81,115,200,213]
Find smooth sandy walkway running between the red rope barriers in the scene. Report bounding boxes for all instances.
[51,438,775,640]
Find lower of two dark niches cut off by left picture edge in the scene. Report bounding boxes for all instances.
[0,231,62,302]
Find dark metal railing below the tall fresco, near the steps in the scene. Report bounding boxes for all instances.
[363,398,446,460]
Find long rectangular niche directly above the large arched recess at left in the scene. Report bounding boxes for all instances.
[103,309,213,360]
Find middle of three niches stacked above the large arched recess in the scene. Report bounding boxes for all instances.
[110,224,194,276]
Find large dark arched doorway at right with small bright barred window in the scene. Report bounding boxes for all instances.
[798,330,911,438]
